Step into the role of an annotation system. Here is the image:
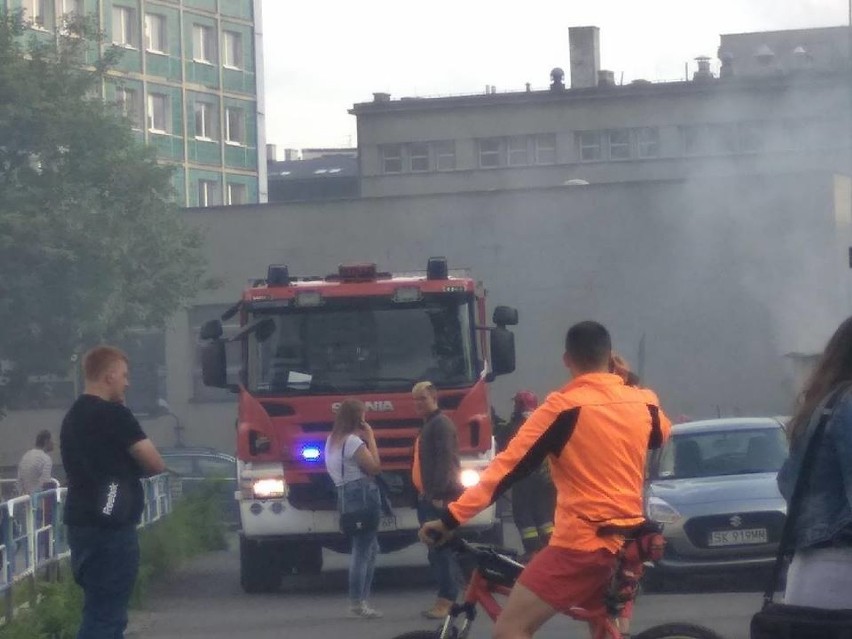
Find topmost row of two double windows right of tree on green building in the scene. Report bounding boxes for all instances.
[112,6,244,69]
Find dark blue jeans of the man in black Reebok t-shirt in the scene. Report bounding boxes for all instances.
[68,525,139,639]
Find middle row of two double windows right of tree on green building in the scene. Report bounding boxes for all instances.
[116,87,247,146]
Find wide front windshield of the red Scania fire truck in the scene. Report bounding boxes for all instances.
[247,294,480,395]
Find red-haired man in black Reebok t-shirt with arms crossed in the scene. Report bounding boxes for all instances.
[59,346,165,639]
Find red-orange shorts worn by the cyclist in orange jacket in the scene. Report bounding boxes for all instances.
[518,546,615,619]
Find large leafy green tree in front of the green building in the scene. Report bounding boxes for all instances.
[0,11,204,410]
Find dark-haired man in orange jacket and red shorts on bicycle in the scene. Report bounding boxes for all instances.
[420,322,671,639]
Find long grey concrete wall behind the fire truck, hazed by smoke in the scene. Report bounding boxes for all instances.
[0,173,852,463]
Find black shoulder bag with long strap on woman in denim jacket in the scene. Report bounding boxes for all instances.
[750,385,852,639]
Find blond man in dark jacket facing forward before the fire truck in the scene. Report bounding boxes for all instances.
[411,382,462,619]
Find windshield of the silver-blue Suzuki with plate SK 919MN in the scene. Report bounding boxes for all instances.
[656,426,787,479]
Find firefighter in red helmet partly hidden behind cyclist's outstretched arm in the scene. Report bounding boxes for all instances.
[509,390,556,561]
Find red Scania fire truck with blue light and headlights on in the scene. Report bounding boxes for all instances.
[200,258,518,592]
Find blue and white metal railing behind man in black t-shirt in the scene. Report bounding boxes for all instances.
[0,473,172,618]
